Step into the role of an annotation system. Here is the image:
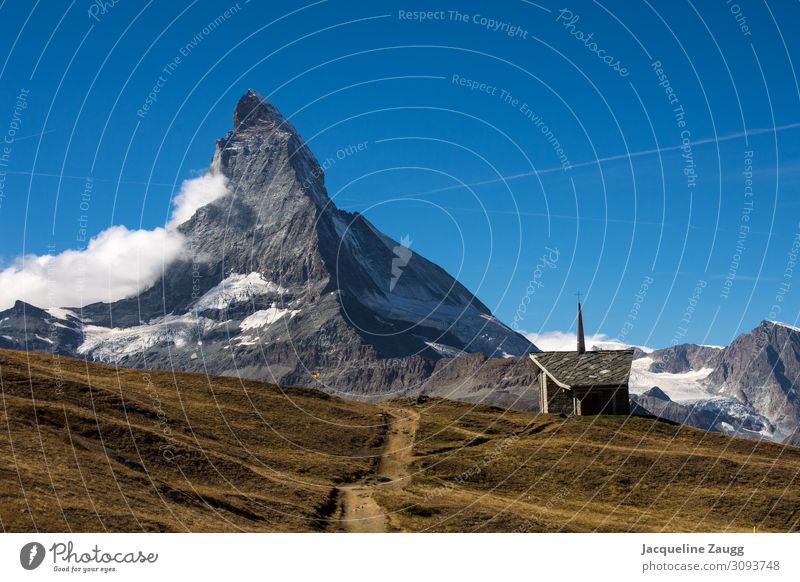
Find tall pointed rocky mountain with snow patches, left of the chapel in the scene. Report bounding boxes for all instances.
[0,91,536,406]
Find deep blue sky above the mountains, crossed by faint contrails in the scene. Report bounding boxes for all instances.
[0,0,800,346]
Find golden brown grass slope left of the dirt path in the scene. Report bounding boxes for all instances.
[0,351,384,531]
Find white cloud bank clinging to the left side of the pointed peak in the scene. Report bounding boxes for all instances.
[0,167,228,309]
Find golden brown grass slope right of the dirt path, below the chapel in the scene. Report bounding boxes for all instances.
[376,400,800,532]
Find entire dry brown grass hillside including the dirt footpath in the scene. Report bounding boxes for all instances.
[0,351,800,531]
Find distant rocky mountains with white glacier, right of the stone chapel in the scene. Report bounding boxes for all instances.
[631,321,800,440]
